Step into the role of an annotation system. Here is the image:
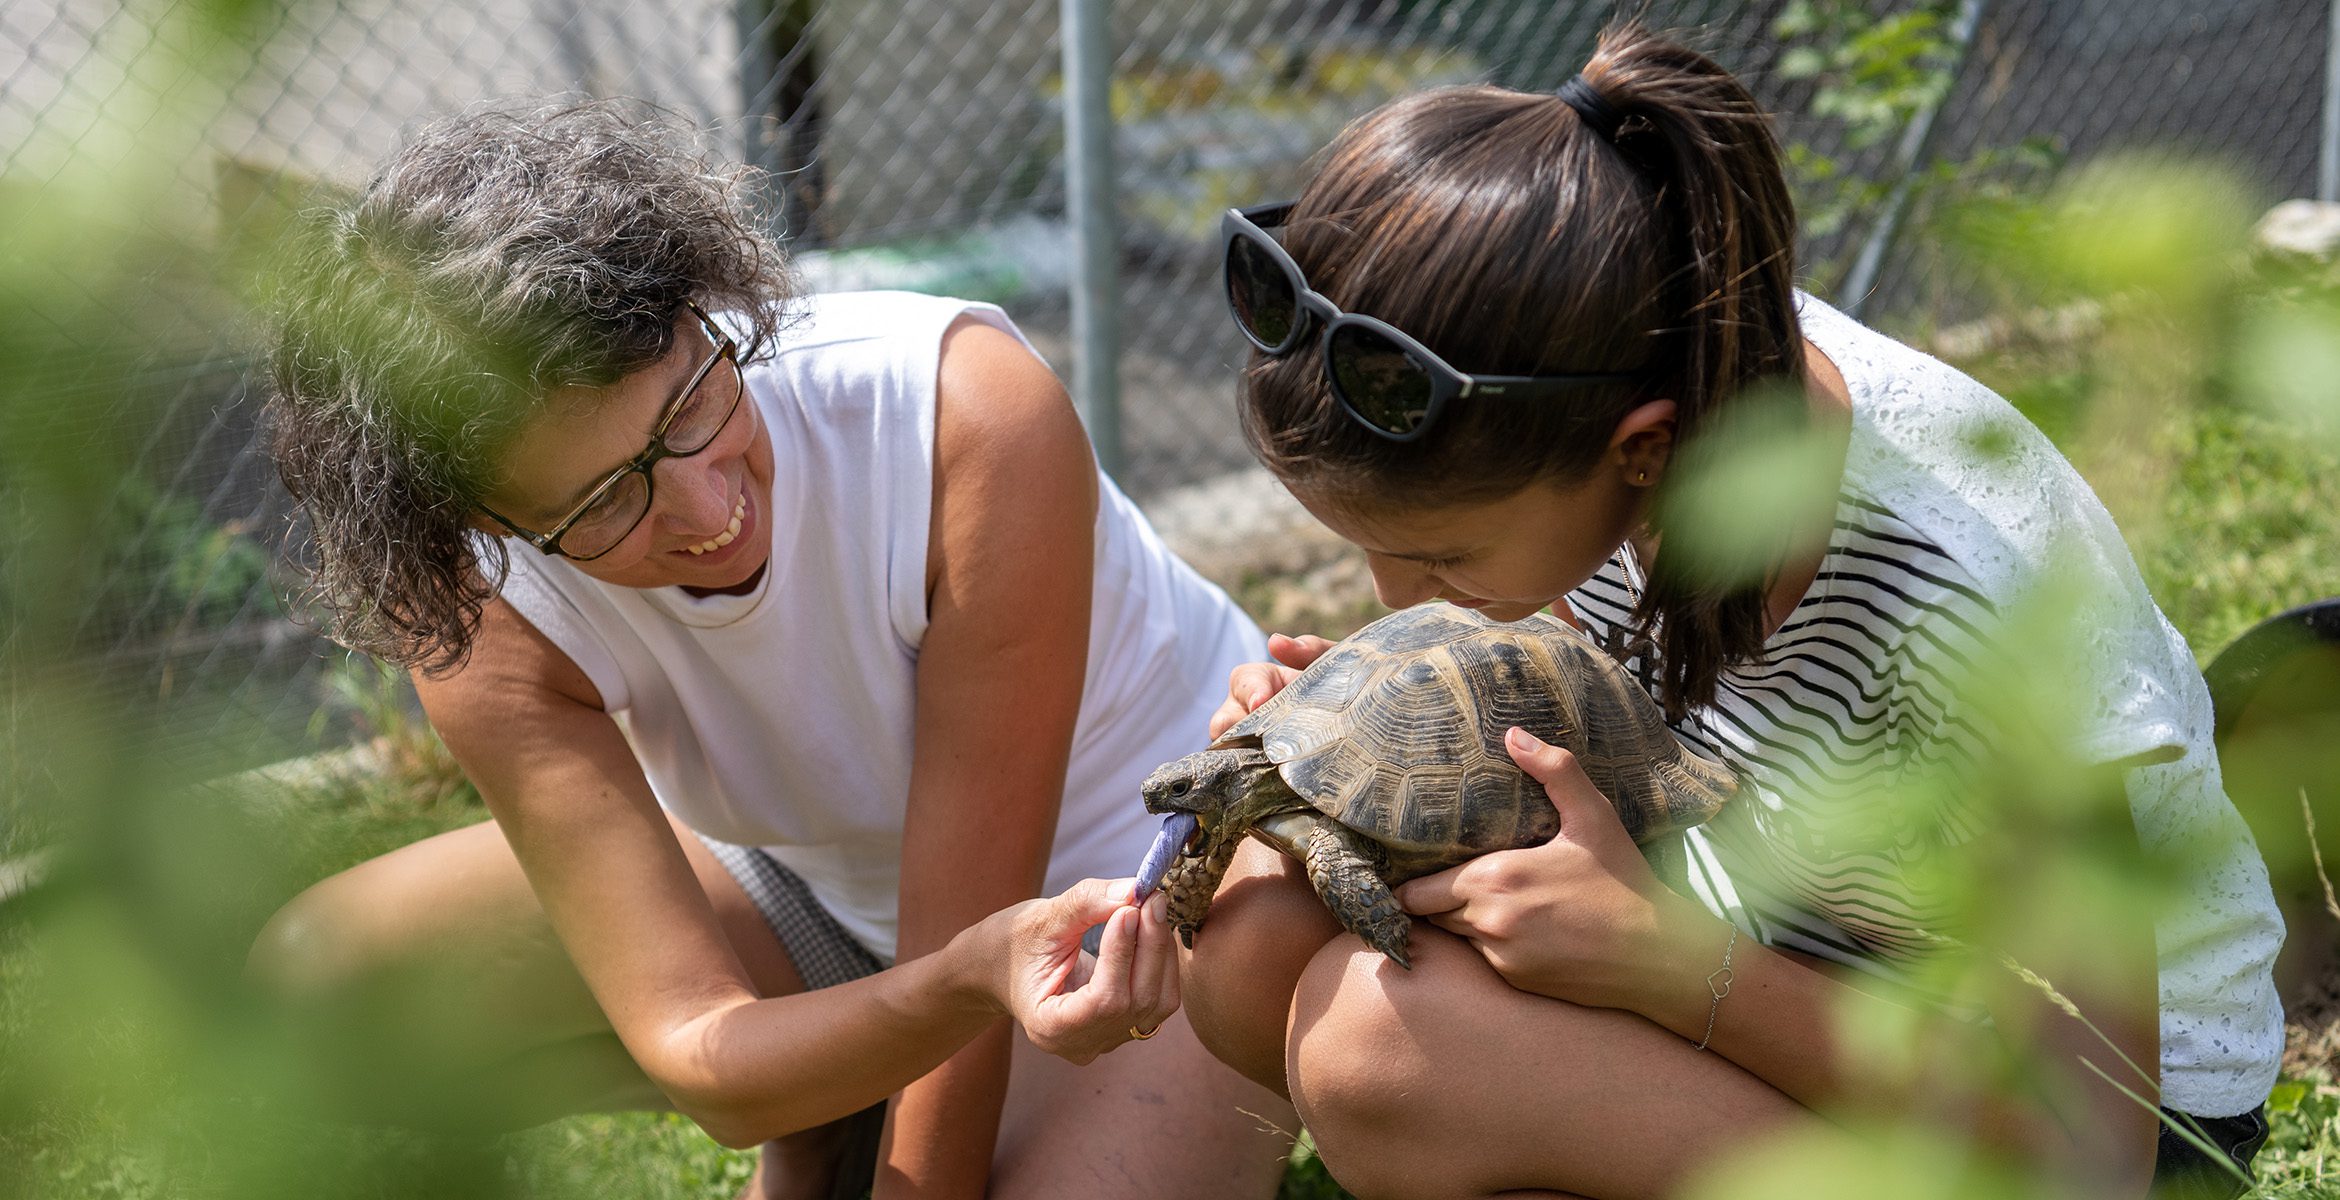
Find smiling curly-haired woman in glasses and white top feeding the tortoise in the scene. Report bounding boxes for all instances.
[253,103,1287,1195]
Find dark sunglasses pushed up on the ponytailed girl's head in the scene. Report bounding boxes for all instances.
[1219,201,1633,442]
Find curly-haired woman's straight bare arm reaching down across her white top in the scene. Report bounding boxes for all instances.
[878,318,1099,1200]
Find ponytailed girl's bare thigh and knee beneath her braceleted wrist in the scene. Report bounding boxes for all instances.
[1287,924,1811,1198]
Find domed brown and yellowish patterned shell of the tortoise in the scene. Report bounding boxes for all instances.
[1217,604,1736,877]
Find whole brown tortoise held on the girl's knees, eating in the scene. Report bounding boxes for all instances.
[1137,604,1736,968]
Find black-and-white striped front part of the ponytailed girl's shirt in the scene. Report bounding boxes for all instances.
[1570,496,1996,1001]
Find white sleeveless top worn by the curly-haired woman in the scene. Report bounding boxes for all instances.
[503,292,1266,959]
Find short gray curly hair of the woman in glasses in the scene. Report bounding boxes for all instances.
[269,101,793,674]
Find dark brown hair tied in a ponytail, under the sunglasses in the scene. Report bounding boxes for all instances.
[1243,21,1804,716]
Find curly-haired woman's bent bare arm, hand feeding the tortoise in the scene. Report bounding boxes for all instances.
[417,601,1168,1146]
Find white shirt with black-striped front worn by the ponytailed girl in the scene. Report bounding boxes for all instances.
[1568,297,2282,1116]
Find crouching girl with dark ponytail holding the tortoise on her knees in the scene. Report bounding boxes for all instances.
[1186,23,2282,1195]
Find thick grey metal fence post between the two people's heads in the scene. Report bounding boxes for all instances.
[1060,0,1121,477]
